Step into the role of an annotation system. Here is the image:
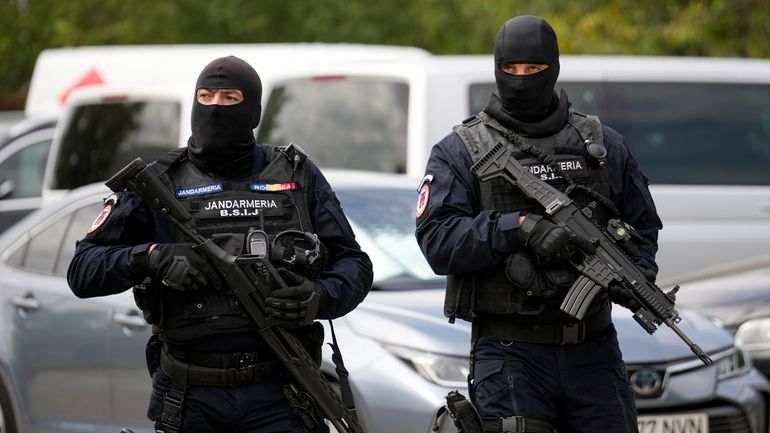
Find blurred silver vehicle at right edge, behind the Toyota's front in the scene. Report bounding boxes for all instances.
[676,255,770,377]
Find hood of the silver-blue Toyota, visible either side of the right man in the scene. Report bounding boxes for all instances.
[345,289,733,364]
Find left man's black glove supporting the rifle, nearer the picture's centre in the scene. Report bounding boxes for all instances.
[265,268,326,327]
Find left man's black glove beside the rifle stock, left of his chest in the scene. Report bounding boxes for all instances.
[147,244,225,290]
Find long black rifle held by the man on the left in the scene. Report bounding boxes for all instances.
[105,158,364,433]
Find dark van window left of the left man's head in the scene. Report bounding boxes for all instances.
[51,101,181,189]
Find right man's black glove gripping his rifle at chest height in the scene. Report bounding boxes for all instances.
[519,214,596,258]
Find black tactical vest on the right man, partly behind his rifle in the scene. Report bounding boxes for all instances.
[444,112,611,321]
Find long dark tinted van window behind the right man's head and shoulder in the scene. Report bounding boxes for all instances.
[469,82,770,185]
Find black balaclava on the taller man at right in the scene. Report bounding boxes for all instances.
[495,15,559,122]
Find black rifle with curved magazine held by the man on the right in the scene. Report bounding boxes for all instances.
[471,143,712,365]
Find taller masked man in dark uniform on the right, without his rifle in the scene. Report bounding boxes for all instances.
[416,16,662,433]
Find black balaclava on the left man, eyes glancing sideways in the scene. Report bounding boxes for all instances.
[187,56,262,174]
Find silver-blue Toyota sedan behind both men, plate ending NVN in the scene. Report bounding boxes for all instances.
[0,171,768,433]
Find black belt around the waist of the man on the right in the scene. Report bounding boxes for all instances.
[473,304,612,345]
